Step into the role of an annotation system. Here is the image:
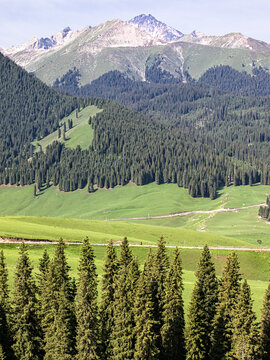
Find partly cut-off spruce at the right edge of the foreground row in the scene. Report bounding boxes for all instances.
[260,282,270,360]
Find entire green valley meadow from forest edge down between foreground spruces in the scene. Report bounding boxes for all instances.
[0,183,270,315]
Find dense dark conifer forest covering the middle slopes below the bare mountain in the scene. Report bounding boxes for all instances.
[0,51,270,199]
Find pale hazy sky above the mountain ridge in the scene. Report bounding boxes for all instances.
[0,0,270,48]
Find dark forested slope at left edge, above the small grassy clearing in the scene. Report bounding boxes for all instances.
[0,53,81,162]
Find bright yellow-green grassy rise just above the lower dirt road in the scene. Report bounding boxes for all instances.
[0,217,248,247]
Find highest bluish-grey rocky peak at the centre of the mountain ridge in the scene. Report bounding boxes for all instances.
[129,14,184,43]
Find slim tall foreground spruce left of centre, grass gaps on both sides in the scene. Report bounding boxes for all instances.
[76,238,100,360]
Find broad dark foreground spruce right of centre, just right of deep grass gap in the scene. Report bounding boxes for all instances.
[186,246,218,360]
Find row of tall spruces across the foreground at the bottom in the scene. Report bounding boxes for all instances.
[0,238,270,360]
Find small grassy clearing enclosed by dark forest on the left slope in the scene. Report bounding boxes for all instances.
[32,105,102,151]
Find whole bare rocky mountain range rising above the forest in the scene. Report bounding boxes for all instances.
[4,15,270,86]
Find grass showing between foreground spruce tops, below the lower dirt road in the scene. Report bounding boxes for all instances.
[0,244,270,316]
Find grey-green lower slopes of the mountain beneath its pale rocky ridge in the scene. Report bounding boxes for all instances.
[24,34,270,85]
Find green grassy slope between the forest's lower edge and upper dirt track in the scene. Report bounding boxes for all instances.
[0,183,270,221]
